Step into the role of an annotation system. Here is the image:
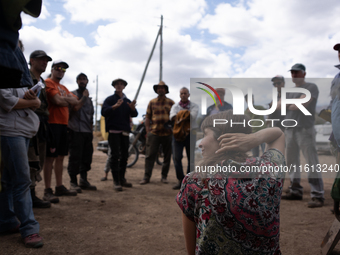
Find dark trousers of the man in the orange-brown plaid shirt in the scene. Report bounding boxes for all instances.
[144,133,172,180]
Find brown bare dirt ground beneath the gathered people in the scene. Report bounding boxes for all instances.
[0,133,340,255]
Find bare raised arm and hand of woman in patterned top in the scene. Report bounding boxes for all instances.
[216,127,285,154]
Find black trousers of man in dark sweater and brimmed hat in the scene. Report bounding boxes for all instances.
[109,133,129,185]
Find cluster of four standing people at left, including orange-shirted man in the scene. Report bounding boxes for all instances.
[0,47,96,248]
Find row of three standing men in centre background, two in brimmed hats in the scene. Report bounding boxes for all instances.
[101,78,198,191]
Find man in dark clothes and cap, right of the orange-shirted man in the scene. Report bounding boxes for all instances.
[67,73,97,193]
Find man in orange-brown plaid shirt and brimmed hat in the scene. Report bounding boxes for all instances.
[139,81,175,185]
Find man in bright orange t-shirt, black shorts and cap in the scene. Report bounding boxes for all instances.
[43,60,89,203]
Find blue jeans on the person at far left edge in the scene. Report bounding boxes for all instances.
[0,136,39,238]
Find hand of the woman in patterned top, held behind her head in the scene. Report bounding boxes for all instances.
[216,133,255,153]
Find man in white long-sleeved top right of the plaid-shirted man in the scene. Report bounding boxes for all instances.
[170,87,198,189]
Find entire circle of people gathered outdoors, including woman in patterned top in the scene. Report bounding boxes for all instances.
[0,1,340,254]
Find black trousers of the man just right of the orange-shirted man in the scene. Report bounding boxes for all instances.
[67,130,93,183]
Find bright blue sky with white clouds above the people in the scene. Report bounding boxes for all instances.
[20,0,340,123]
